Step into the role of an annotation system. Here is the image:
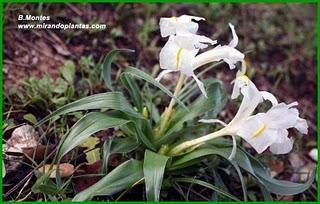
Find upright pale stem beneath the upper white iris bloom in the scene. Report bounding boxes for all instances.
[155,74,186,139]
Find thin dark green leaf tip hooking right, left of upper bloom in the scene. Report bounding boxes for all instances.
[102,49,134,91]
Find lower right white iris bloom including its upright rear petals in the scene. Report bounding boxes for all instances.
[226,75,308,154]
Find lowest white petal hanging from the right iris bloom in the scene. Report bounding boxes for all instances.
[270,129,294,154]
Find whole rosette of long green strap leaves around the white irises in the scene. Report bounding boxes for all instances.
[33,49,315,201]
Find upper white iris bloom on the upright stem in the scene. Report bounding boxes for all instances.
[156,15,244,97]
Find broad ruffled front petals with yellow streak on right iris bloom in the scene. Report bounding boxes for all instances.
[237,102,308,154]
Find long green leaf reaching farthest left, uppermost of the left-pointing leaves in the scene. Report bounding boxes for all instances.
[37,92,143,126]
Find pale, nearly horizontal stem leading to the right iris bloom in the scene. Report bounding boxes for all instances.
[167,128,229,156]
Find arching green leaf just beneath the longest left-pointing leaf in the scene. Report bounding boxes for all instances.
[57,112,130,161]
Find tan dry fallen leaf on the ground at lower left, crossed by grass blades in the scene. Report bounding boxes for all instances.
[38,163,75,178]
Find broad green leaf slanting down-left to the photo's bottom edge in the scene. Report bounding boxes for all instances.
[73,160,143,201]
